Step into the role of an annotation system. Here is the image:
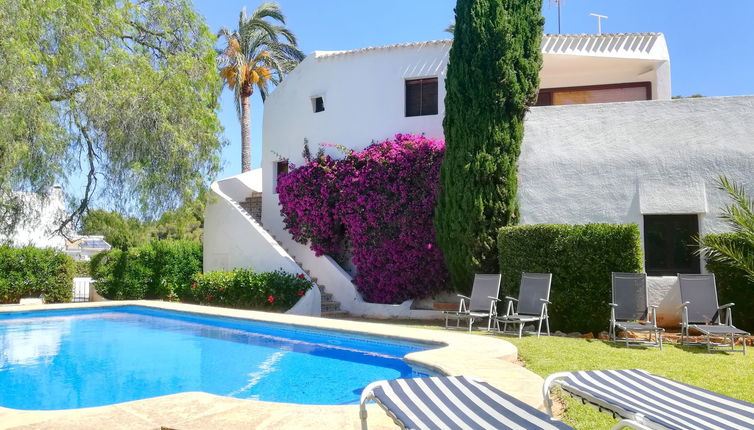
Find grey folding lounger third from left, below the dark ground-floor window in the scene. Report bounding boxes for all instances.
[610,272,664,349]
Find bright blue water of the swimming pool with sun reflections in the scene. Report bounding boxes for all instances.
[0,306,435,409]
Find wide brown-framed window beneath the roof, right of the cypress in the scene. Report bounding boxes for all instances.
[536,82,652,106]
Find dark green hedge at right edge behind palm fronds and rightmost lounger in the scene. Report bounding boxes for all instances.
[702,233,754,331]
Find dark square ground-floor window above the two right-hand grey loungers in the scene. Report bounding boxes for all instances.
[644,215,700,276]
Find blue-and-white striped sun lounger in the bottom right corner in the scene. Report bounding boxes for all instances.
[544,369,754,430]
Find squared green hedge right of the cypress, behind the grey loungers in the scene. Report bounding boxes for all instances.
[498,224,642,333]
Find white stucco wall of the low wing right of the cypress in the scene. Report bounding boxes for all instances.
[519,96,754,239]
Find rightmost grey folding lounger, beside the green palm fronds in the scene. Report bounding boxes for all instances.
[678,274,751,354]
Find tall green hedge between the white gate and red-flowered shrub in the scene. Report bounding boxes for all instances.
[91,240,202,300]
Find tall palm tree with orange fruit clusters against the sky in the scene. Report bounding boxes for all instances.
[217,2,304,172]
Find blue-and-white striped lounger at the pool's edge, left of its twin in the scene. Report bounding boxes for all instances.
[360,376,572,430]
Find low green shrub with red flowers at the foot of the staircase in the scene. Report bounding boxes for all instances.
[177,269,313,310]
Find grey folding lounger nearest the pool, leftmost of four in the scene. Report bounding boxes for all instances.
[443,274,501,331]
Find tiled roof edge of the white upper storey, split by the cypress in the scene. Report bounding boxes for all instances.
[314,33,667,59]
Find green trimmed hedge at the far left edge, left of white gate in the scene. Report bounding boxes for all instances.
[0,246,74,303]
